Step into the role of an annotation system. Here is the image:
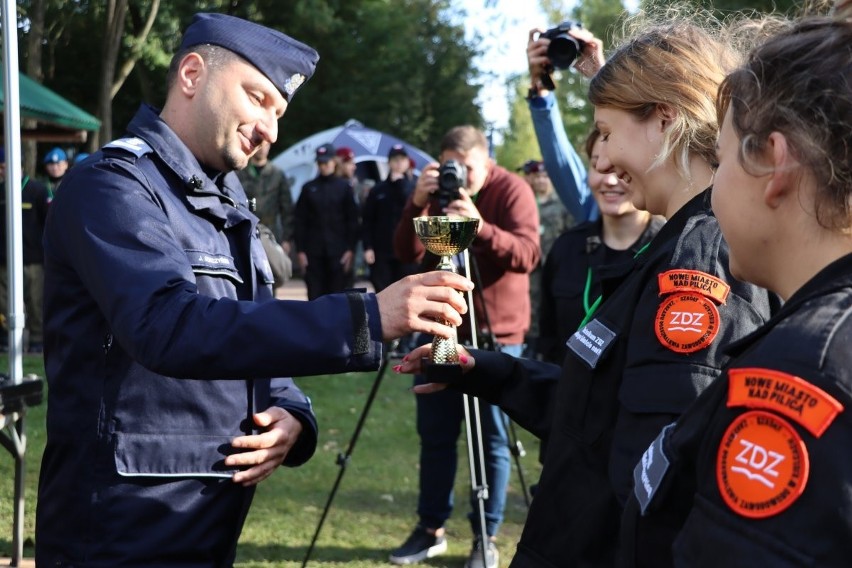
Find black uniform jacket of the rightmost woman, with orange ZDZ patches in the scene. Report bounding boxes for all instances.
[623,255,852,568]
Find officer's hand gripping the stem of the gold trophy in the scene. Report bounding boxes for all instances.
[376,270,473,341]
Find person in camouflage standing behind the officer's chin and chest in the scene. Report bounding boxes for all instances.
[237,138,295,288]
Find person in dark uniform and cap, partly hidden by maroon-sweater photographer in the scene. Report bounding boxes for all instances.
[362,144,418,292]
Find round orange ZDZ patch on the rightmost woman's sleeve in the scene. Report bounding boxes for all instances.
[716,410,810,519]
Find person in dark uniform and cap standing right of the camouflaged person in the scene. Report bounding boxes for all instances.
[295,144,358,300]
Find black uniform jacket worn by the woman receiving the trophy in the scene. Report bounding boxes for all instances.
[452,190,773,567]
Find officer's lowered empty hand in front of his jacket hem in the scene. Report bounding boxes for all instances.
[225,406,302,487]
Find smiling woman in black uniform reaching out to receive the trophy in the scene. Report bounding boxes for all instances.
[399,20,777,567]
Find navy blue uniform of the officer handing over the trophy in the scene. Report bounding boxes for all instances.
[36,106,381,567]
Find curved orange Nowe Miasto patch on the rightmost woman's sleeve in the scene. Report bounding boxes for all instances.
[728,368,843,438]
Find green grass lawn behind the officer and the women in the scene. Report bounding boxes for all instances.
[0,356,540,568]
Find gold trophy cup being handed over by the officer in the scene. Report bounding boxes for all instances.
[414,216,479,379]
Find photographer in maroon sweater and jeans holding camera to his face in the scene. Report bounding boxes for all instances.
[390,126,541,568]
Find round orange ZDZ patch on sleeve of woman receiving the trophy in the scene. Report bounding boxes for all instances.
[654,294,719,353]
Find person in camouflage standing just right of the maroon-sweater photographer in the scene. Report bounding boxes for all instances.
[518,160,575,357]
